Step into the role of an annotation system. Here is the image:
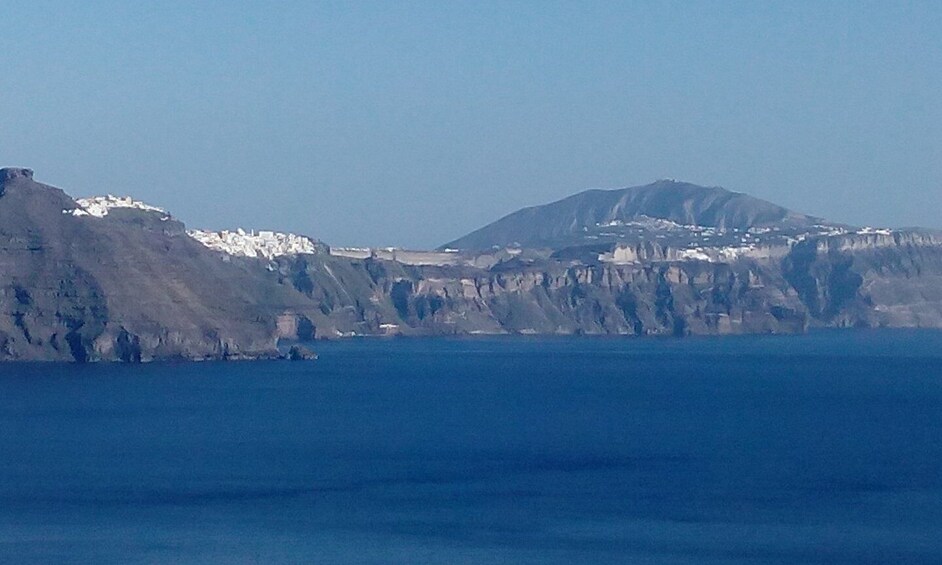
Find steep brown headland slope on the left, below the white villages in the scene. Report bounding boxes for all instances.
[0,169,318,361]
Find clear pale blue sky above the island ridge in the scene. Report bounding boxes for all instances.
[0,0,942,247]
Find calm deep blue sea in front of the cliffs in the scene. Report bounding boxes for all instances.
[0,331,942,564]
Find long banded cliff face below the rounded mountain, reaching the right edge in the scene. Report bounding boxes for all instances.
[270,229,942,337]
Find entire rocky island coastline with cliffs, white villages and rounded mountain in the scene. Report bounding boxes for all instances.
[0,169,942,362]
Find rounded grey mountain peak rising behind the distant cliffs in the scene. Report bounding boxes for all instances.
[442,180,826,250]
